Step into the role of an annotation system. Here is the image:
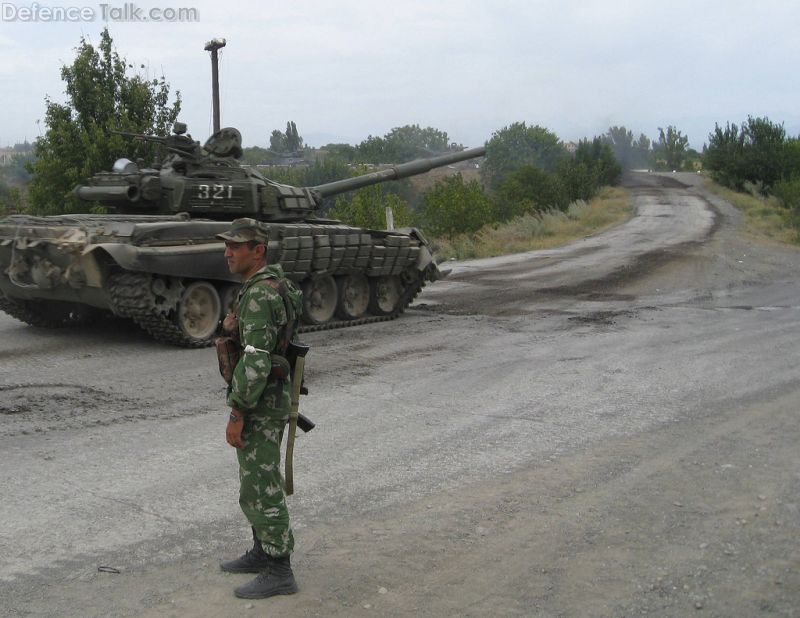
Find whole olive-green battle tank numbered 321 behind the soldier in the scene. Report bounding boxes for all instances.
[0,123,485,347]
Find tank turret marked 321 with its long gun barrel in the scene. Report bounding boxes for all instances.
[75,123,486,222]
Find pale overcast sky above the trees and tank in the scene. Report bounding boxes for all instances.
[0,0,800,149]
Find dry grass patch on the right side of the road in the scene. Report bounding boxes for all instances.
[705,179,800,245]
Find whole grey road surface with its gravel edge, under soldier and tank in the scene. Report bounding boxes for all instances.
[0,174,800,617]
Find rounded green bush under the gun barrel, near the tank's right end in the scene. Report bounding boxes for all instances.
[423,174,494,239]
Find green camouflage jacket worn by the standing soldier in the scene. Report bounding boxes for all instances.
[227,264,302,417]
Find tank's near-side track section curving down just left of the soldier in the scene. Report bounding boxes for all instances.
[108,272,211,348]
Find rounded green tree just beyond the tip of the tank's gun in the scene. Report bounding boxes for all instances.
[481,122,569,189]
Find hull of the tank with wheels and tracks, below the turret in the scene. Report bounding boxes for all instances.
[0,215,439,347]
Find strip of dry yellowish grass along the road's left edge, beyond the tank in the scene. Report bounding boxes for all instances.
[434,187,633,260]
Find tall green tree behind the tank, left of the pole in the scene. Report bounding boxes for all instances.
[28,28,181,214]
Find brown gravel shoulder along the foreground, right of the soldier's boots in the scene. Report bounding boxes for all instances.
[145,376,800,616]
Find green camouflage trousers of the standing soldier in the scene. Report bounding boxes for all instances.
[236,414,294,558]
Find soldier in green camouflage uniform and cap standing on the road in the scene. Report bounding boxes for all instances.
[218,219,302,598]
